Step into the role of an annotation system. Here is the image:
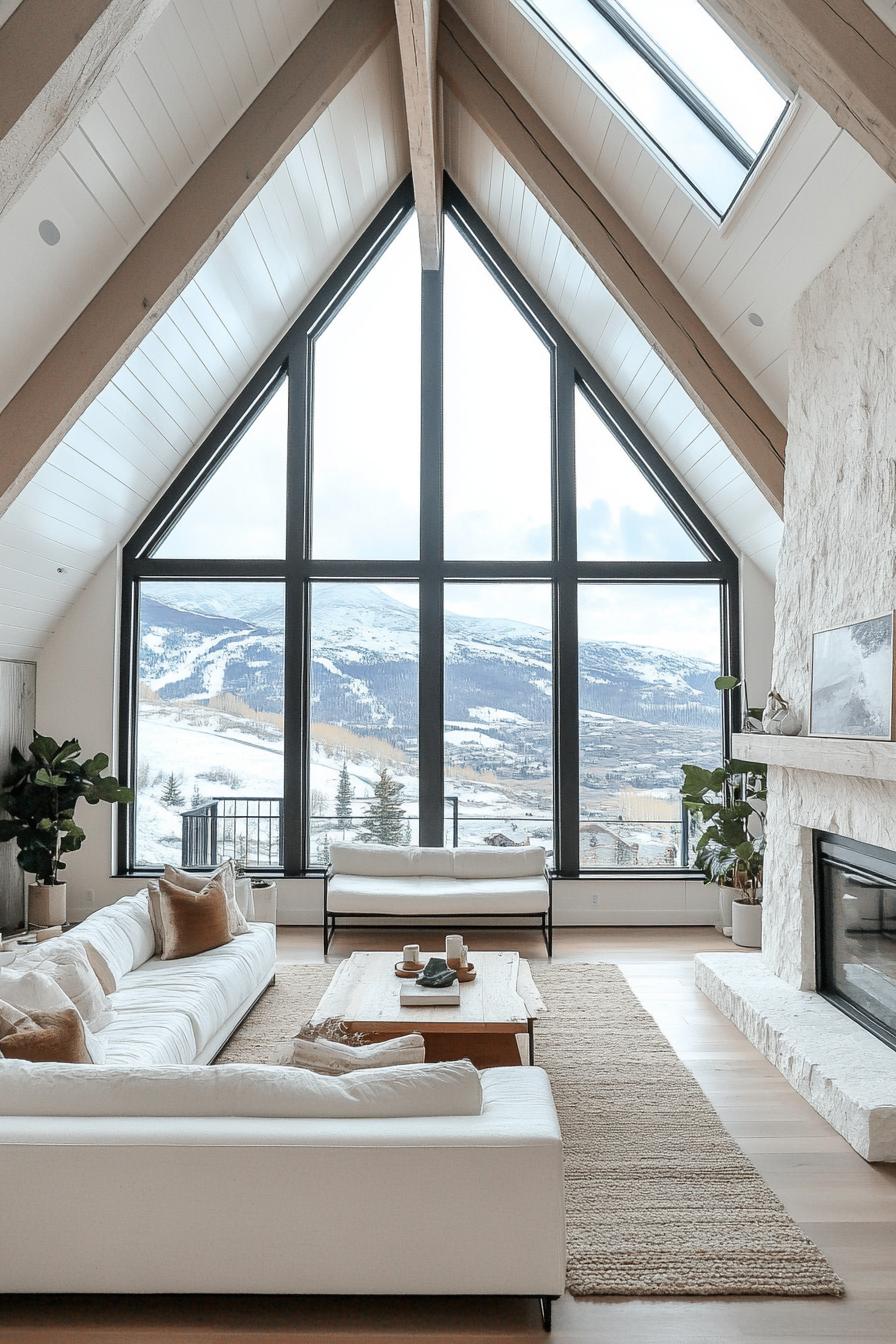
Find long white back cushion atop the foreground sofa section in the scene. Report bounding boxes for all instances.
[3,1059,482,1112]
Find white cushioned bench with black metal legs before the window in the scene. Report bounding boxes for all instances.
[324,843,553,957]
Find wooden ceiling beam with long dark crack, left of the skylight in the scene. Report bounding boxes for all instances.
[439,5,787,512]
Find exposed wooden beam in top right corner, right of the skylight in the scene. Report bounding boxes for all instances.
[712,0,896,179]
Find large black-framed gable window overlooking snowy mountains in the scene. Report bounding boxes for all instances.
[121,183,737,875]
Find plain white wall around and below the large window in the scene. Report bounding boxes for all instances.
[38,537,772,925]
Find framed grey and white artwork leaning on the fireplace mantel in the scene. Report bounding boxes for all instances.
[809,612,893,742]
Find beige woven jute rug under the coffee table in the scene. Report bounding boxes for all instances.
[219,962,842,1297]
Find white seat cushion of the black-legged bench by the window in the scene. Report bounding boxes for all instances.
[326,874,548,915]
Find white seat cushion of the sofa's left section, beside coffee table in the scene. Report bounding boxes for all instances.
[110,925,275,1059]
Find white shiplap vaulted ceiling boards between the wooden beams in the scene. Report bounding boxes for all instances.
[0,0,893,657]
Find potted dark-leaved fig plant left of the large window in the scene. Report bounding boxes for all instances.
[0,732,133,927]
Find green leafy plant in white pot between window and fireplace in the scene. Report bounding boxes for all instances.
[681,761,768,948]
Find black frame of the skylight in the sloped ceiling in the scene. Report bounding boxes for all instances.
[525,0,793,224]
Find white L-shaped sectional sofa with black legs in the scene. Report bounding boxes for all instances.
[0,894,566,1322]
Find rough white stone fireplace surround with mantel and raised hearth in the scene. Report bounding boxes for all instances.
[697,194,896,1161]
